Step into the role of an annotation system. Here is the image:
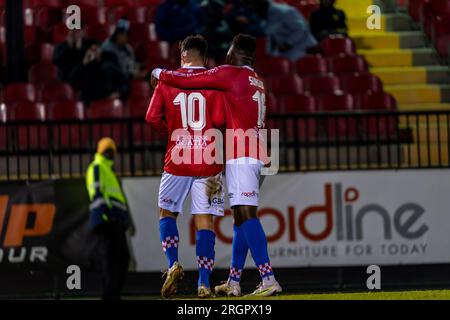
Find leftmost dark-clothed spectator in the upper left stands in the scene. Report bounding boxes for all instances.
[53,30,91,81]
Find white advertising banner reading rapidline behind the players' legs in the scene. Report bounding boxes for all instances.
[123,170,450,271]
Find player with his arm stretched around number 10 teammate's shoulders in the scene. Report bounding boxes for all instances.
[152,34,282,296]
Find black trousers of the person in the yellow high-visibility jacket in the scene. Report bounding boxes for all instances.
[93,219,130,300]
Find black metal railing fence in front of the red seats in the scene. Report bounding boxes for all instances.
[0,111,450,180]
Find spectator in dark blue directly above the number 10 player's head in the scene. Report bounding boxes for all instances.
[155,0,201,43]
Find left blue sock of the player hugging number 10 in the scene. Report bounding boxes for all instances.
[228,225,248,283]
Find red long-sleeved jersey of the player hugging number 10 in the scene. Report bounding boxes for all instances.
[159,65,267,163]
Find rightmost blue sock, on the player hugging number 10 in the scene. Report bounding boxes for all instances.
[242,218,274,280]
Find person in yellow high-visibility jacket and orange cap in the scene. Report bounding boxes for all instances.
[86,138,130,300]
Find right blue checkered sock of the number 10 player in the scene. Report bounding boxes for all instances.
[196,230,216,288]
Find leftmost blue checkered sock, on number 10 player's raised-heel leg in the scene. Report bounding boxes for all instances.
[159,217,180,269]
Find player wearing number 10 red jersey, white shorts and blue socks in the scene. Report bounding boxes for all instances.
[146,36,225,298]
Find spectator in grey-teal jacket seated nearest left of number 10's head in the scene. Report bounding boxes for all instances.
[102,19,147,79]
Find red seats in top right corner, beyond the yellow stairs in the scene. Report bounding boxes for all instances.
[408,0,450,58]
